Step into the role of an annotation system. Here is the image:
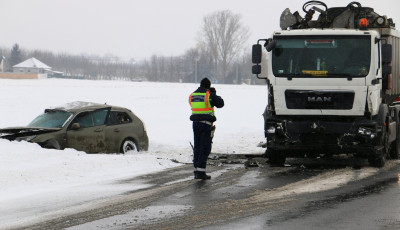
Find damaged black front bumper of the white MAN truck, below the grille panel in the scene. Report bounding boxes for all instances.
[265,117,381,157]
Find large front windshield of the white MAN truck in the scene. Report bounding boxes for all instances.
[272,35,371,78]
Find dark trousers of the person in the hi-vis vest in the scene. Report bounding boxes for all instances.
[193,122,212,172]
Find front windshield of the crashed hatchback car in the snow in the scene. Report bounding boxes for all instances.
[28,110,72,128]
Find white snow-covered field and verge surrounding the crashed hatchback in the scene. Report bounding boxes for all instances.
[0,79,267,228]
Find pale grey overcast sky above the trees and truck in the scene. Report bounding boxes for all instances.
[0,0,400,59]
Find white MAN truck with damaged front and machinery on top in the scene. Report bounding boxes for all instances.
[252,1,400,167]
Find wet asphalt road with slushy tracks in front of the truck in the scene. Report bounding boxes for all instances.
[10,155,400,229]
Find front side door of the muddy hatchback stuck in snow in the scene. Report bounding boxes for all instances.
[67,108,109,153]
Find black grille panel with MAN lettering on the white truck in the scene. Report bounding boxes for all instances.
[285,90,354,110]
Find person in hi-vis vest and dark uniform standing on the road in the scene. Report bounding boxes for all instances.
[189,78,224,180]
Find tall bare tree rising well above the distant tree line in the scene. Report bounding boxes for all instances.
[202,10,249,82]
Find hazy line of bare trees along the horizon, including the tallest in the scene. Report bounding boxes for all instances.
[0,10,260,84]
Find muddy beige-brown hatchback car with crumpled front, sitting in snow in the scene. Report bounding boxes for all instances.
[0,102,149,153]
